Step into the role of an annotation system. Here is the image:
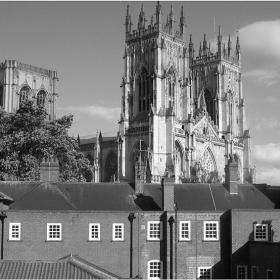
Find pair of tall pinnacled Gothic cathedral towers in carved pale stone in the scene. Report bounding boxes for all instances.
[118,2,253,186]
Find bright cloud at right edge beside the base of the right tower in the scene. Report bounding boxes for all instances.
[252,143,280,165]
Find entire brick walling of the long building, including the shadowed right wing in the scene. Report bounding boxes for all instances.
[4,210,280,279]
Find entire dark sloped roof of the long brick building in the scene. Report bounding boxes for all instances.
[0,182,274,211]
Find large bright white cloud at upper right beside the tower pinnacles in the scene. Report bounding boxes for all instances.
[239,19,280,60]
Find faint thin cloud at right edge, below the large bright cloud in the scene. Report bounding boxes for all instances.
[242,69,280,87]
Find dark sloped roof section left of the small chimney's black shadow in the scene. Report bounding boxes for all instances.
[0,182,138,211]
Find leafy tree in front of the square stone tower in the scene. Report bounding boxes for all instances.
[0,101,92,181]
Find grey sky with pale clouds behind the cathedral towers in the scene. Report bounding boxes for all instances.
[0,1,280,185]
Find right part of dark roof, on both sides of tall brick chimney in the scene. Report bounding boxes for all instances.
[141,183,274,211]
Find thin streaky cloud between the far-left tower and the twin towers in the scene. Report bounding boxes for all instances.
[57,105,121,121]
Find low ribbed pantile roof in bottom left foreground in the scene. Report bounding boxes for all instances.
[0,256,118,279]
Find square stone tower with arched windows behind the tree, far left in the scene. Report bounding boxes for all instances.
[0,60,58,120]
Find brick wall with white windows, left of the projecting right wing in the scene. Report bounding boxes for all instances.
[4,210,230,278]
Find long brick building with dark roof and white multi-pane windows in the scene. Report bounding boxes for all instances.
[0,180,280,279]
